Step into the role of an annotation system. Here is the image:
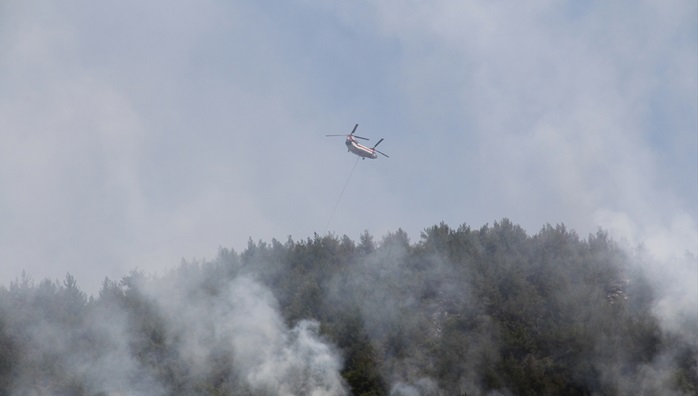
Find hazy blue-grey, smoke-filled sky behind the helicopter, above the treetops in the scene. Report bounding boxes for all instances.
[0,0,698,293]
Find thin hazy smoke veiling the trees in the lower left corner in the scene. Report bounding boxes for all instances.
[7,281,167,396]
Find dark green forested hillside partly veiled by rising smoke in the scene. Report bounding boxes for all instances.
[0,219,698,396]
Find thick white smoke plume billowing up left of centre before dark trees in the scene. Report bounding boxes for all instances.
[147,276,347,396]
